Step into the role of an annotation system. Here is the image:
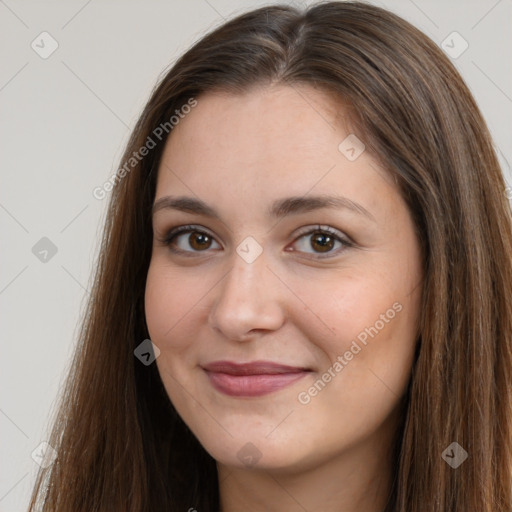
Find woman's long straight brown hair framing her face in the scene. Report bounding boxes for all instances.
[30,2,512,512]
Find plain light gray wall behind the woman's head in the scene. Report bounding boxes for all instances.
[0,0,512,512]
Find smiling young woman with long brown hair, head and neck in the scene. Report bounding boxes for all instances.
[30,2,512,512]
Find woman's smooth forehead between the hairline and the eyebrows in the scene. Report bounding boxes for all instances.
[157,86,396,218]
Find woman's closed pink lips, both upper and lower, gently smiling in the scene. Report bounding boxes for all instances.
[202,361,311,397]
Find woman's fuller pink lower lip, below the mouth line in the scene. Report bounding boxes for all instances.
[206,371,309,397]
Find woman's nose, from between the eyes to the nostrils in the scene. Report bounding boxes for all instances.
[209,247,286,341]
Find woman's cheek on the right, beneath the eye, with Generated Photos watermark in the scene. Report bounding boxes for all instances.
[295,268,421,384]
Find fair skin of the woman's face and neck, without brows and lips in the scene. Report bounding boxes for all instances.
[145,85,422,512]
